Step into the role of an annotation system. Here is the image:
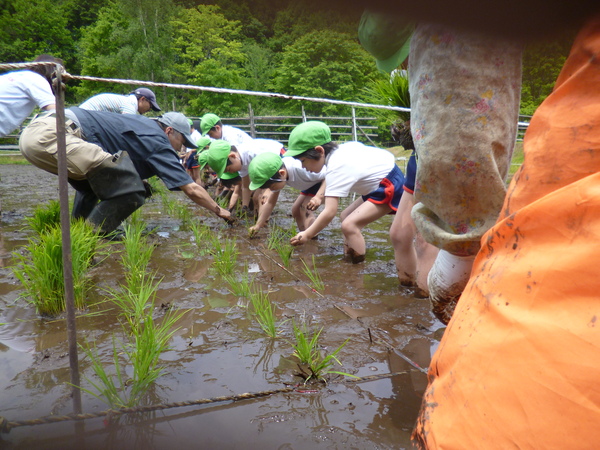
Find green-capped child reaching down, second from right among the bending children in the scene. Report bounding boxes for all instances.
[248,153,326,235]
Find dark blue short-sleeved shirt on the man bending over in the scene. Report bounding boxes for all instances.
[70,107,193,190]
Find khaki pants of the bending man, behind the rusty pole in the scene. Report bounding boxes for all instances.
[19,115,112,180]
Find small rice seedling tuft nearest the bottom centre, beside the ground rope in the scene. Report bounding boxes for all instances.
[292,322,356,384]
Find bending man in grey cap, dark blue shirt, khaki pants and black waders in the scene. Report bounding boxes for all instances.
[19,108,231,234]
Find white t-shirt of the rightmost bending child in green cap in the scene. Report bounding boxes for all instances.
[325,142,396,197]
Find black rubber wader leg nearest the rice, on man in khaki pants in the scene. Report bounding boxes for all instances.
[87,152,146,234]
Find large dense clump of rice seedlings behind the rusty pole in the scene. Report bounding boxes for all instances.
[12,221,106,316]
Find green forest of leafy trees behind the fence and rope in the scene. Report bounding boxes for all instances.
[0,0,574,139]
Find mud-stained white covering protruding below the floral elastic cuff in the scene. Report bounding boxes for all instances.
[427,250,475,325]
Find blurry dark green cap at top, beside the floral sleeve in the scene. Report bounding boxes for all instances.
[358,10,415,72]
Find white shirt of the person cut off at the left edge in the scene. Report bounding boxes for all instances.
[0,70,55,137]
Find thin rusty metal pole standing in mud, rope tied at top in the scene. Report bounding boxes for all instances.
[55,64,81,414]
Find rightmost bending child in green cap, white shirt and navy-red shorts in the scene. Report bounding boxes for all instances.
[286,121,404,263]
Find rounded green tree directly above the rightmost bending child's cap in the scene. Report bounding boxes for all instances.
[273,30,377,115]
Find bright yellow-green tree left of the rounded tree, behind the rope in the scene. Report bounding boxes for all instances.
[172,5,247,116]
